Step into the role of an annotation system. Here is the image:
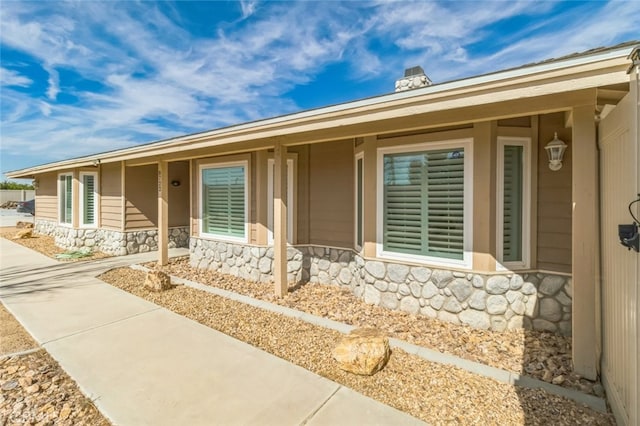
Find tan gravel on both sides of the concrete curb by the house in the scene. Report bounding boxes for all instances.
[100,268,614,425]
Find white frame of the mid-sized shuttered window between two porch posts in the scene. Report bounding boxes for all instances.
[198,160,251,244]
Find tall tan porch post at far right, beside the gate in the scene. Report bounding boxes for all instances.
[569,105,599,380]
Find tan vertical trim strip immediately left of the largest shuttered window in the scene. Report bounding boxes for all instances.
[362,136,378,258]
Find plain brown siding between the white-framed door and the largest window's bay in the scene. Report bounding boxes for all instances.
[309,140,354,247]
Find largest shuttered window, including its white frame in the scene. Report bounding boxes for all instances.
[378,140,472,267]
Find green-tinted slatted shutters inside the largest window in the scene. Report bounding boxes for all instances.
[383,148,464,259]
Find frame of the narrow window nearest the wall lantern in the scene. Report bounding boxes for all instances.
[496,136,531,271]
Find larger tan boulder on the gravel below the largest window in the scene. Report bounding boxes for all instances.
[333,328,390,376]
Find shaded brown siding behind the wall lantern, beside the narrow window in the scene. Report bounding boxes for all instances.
[537,113,572,273]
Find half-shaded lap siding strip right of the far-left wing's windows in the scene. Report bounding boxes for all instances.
[100,163,122,229]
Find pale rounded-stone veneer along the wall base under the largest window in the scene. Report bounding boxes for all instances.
[189,237,572,335]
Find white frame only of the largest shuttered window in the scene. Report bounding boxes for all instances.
[376,138,473,269]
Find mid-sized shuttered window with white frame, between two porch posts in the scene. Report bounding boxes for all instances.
[200,161,249,242]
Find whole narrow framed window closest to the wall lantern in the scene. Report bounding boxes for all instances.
[496,138,530,269]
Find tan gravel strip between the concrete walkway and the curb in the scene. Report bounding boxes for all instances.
[100,268,614,425]
